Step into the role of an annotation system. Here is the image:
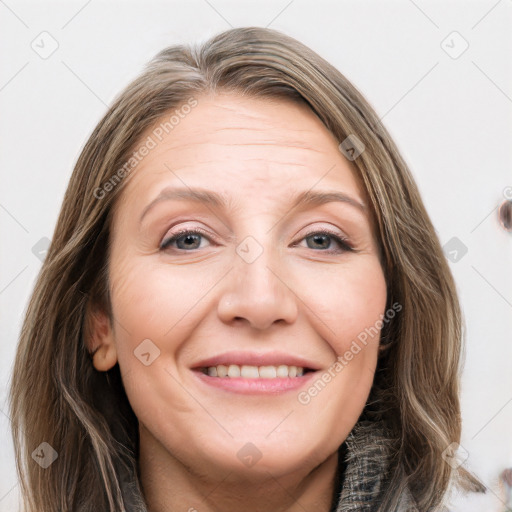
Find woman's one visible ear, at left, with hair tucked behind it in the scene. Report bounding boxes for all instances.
[86,308,117,372]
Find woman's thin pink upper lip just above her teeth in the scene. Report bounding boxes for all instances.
[193,351,319,370]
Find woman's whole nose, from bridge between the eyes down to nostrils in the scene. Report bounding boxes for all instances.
[218,230,297,329]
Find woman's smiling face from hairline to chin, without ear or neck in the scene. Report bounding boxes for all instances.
[96,94,386,476]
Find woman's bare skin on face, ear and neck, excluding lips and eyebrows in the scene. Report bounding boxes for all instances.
[91,93,386,512]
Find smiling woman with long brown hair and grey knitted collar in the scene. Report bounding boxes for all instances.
[11,28,484,512]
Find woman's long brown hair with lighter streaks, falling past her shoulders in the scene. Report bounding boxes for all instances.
[10,28,481,512]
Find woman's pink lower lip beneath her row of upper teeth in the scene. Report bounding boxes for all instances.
[193,371,316,395]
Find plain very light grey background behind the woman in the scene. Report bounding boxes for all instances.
[0,0,512,512]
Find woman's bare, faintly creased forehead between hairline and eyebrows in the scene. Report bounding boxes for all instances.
[115,93,365,214]
